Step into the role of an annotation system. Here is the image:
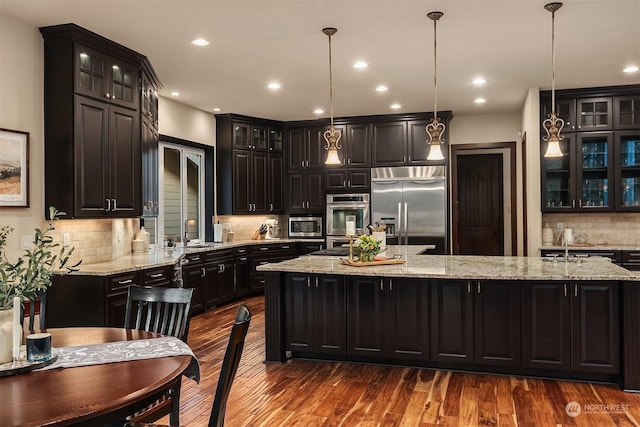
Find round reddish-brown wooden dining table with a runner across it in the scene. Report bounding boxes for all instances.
[0,328,191,427]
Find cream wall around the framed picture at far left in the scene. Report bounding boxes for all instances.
[0,14,44,259]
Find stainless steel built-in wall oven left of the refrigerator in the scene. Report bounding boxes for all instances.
[325,193,369,248]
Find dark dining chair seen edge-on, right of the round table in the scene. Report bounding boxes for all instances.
[126,303,251,427]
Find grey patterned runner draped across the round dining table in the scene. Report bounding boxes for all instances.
[37,337,200,383]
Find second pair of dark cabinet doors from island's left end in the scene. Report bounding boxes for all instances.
[347,277,429,360]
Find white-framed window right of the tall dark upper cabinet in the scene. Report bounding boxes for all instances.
[158,142,205,244]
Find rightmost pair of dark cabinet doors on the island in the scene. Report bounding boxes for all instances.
[522,281,620,374]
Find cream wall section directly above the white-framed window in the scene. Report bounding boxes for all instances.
[158,96,216,146]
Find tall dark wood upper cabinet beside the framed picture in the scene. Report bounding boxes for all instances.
[40,24,162,219]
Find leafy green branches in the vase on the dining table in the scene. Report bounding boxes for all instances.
[0,206,82,310]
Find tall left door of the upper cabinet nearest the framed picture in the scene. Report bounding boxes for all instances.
[75,96,111,217]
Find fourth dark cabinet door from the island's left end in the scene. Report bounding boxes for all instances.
[385,279,429,360]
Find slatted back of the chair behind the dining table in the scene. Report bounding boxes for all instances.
[124,286,193,342]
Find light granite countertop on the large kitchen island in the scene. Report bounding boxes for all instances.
[257,246,640,281]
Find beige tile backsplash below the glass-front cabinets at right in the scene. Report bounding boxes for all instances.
[542,213,640,246]
